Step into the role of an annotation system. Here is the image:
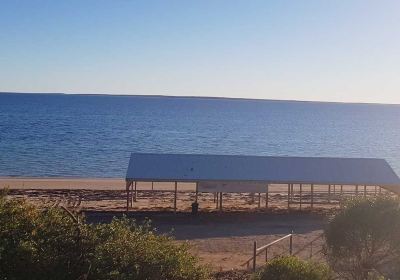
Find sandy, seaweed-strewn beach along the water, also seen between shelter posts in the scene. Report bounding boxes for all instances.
[0,177,356,212]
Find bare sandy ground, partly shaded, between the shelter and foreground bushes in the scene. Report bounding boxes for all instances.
[87,212,326,271]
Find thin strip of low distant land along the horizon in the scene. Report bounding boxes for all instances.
[0,91,400,106]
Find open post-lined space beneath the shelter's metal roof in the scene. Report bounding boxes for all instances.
[126,181,396,212]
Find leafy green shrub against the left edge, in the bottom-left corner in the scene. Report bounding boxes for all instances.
[0,194,92,279]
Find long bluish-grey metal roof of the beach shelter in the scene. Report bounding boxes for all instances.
[126,153,400,189]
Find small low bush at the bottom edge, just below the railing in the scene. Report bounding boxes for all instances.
[252,257,333,280]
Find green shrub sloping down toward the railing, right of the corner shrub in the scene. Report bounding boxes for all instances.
[92,218,207,280]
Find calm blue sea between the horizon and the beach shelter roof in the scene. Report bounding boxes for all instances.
[0,94,400,177]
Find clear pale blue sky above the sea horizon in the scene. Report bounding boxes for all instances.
[0,0,400,104]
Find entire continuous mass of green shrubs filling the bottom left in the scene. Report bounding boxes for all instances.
[0,195,207,280]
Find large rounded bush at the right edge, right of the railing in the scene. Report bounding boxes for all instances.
[325,196,400,280]
